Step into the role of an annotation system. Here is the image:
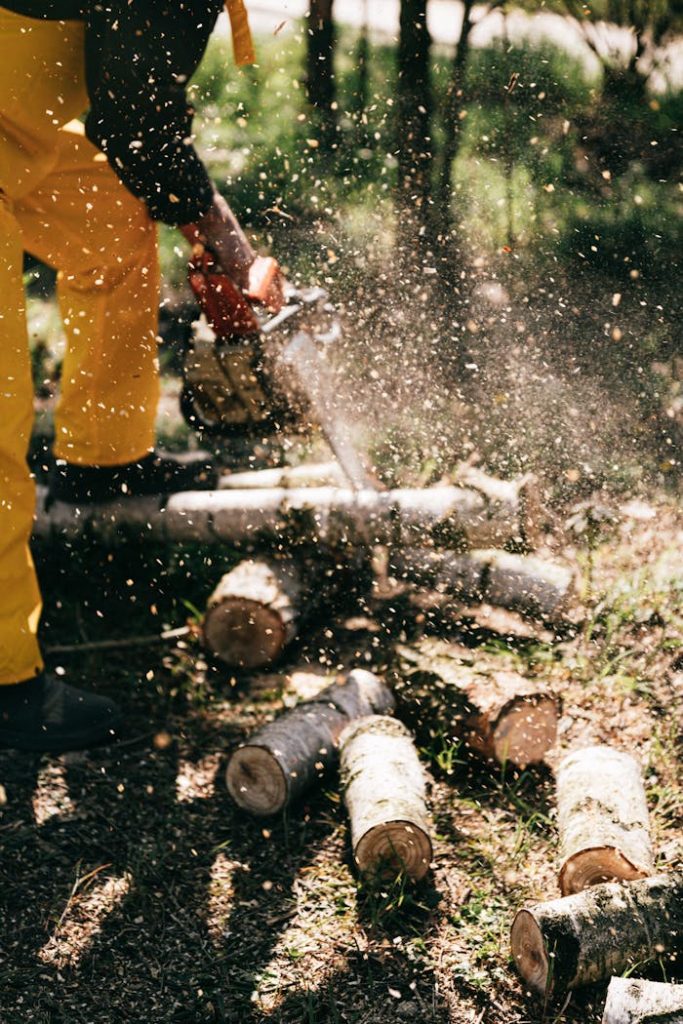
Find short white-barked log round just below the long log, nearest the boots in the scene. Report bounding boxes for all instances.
[203,558,303,669]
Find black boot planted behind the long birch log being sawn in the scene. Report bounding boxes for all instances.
[48,452,218,505]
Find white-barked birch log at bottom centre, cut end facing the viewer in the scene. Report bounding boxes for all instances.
[339,715,432,881]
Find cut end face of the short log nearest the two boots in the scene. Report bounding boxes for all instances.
[204,598,289,669]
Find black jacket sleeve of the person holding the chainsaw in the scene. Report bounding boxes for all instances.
[85,0,222,224]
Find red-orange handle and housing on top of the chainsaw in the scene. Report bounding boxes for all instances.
[188,245,283,338]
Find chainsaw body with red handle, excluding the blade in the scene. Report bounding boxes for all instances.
[181,250,339,446]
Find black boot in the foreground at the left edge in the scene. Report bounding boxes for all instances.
[0,674,121,754]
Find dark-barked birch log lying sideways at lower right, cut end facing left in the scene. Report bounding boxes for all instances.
[511,871,683,998]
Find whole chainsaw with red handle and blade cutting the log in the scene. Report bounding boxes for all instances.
[180,245,374,489]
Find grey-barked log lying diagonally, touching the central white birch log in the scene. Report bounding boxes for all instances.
[225,669,393,815]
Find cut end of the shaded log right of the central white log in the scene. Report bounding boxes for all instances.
[493,695,559,768]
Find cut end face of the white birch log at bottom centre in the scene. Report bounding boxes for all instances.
[354,821,432,882]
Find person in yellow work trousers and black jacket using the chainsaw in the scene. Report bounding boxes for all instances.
[0,0,278,753]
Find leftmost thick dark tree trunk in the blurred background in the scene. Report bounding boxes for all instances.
[306,0,337,146]
